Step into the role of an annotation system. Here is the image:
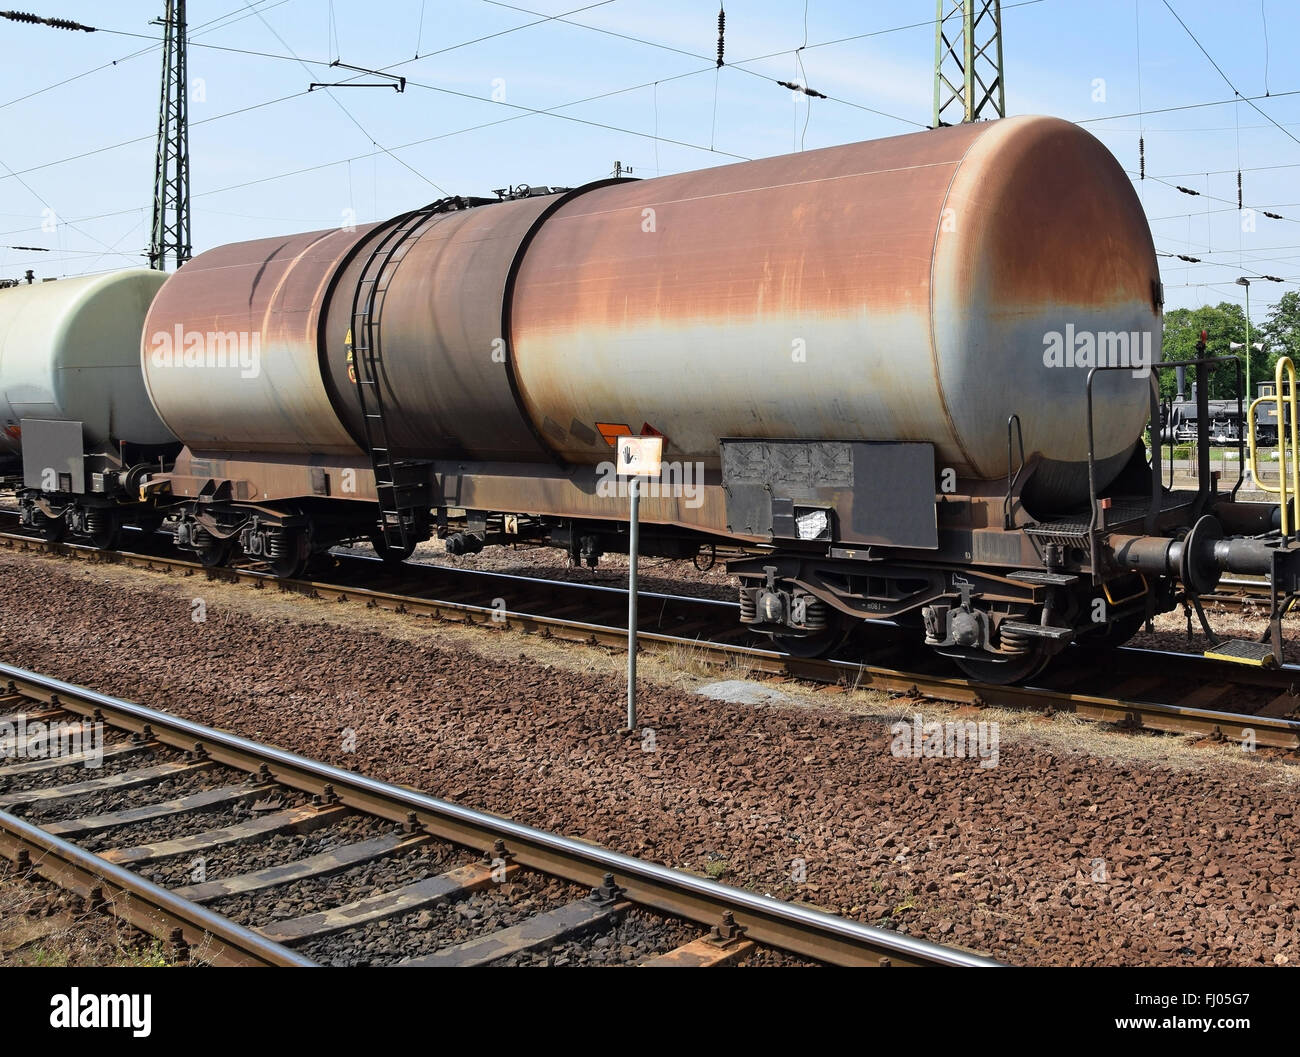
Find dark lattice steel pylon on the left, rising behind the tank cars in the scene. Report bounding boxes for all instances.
[150,0,191,272]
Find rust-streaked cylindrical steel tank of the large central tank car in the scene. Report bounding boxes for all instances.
[143,117,1161,511]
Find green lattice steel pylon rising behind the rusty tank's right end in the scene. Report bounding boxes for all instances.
[933,0,1006,129]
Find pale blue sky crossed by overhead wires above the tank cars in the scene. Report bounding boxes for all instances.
[0,0,1300,320]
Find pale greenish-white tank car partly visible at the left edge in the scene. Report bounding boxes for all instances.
[0,268,181,547]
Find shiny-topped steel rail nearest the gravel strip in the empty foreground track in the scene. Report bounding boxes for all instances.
[0,663,998,967]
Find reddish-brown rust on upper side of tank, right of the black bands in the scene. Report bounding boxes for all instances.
[515,127,978,329]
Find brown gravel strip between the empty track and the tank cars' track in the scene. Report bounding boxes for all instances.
[0,554,1300,965]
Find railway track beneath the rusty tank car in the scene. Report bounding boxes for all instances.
[0,517,1300,750]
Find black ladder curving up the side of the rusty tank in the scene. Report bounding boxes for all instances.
[351,199,459,554]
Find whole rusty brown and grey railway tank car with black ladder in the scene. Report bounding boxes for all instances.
[134,117,1291,681]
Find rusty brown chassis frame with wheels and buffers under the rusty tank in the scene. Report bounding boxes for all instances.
[129,356,1300,681]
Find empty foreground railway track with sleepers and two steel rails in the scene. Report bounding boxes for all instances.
[0,664,995,966]
